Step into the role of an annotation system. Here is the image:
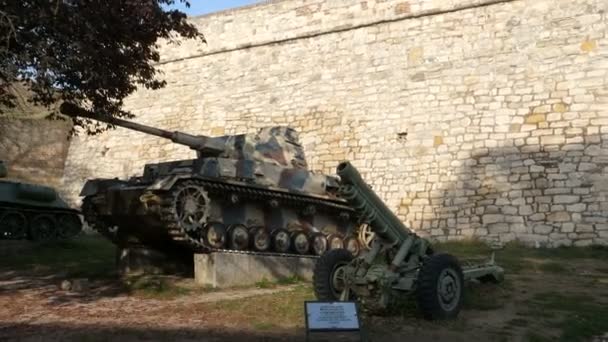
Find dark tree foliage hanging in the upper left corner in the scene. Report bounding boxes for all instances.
[0,0,204,133]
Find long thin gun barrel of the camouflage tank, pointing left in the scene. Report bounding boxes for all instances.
[59,102,225,154]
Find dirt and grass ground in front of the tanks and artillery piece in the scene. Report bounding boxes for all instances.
[0,238,608,341]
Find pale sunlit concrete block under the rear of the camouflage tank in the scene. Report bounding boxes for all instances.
[194,253,317,288]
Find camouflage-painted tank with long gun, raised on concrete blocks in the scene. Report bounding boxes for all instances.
[61,103,361,255]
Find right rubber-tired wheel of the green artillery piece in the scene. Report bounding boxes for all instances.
[416,254,464,320]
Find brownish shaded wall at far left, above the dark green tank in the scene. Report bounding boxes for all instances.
[0,118,71,187]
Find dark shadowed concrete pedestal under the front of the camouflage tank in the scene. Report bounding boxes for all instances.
[116,246,193,276]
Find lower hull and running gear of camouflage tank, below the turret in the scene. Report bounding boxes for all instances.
[83,173,358,254]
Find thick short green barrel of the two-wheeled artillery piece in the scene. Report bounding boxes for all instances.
[337,162,412,244]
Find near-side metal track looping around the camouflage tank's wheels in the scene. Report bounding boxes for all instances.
[161,179,354,254]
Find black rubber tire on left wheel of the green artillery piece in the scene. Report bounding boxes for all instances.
[312,249,354,301]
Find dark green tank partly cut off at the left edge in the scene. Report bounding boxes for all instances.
[0,161,82,241]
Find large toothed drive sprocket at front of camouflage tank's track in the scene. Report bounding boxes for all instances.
[173,181,209,240]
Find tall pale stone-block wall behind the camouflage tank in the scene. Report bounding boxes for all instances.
[65,0,608,246]
